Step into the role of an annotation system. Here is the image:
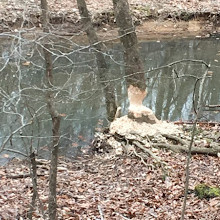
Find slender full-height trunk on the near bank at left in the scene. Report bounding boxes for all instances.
[41,0,60,220]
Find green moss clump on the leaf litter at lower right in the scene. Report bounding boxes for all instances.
[195,184,220,199]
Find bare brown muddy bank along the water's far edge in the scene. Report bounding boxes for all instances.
[0,18,220,44]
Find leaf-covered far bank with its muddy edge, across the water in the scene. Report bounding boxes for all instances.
[0,0,220,40]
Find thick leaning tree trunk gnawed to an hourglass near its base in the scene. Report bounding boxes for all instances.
[113,0,158,124]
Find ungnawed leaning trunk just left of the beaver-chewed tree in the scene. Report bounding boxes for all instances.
[77,0,117,121]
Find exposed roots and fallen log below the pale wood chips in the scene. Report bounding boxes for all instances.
[93,125,220,165]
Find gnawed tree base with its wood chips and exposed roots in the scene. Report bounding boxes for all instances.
[92,85,185,158]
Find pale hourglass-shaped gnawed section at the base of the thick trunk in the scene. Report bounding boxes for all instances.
[128,85,160,124]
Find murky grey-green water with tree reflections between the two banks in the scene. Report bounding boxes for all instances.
[0,35,220,160]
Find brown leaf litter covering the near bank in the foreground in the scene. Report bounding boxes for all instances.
[0,124,220,220]
